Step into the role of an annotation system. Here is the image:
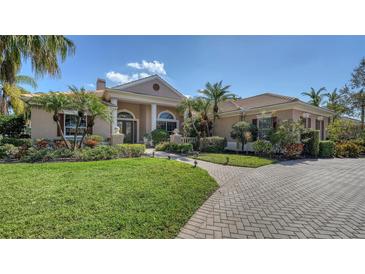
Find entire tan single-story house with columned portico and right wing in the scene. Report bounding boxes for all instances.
[24,75,333,144]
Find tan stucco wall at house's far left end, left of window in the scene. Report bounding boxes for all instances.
[31,107,57,139]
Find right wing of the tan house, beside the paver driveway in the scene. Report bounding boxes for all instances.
[214,93,334,148]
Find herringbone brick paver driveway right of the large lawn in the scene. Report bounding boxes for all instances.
[178,159,365,238]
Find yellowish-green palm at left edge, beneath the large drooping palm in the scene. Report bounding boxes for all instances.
[0,75,37,114]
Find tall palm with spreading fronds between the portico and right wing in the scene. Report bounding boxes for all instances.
[199,81,236,134]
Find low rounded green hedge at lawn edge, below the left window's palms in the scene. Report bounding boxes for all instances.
[75,146,119,161]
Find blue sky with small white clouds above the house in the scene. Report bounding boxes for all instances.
[22,36,365,98]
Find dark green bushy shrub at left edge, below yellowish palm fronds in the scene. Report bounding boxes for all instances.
[0,115,25,137]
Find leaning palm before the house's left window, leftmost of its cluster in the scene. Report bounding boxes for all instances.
[32,92,73,149]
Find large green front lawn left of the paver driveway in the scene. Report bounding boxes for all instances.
[0,158,218,238]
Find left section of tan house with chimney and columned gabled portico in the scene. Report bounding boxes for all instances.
[24,75,184,143]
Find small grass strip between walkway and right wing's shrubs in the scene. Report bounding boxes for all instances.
[196,153,277,167]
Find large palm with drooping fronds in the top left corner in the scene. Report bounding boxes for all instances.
[0,35,75,114]
